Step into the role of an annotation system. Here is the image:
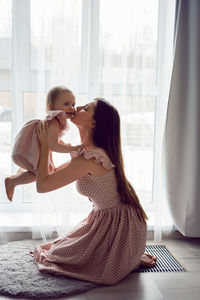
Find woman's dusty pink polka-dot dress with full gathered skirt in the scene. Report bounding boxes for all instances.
[33,149,146,285]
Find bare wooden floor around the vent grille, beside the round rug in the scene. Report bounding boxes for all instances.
[0,236,200,300]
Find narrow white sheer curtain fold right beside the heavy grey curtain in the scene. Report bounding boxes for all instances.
[152,0,175,241]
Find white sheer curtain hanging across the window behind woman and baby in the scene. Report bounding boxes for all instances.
[0,0,175,244]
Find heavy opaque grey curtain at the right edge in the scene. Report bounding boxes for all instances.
[165,0,200,237]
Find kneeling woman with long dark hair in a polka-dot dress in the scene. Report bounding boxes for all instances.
[33,98,156,285]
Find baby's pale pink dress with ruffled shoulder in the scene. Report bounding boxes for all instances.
[12,110,67,171]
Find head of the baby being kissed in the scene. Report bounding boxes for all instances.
[46,86,75,119]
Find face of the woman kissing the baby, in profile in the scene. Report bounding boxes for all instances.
[71,101,96,128]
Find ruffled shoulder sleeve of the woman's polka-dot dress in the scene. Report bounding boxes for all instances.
[83,149,115,170]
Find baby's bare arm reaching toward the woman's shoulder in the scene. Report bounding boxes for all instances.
[48,119,83,153]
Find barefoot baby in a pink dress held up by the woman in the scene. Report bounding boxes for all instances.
[5,86,82,201]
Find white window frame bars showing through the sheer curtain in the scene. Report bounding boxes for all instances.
[0,0,167,220]
